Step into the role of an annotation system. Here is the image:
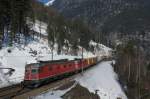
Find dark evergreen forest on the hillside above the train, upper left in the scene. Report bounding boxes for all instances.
[0,0,94,53]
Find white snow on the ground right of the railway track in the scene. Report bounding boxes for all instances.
[34,61,127,99]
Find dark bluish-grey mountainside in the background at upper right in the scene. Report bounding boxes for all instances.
[53,0,150,58]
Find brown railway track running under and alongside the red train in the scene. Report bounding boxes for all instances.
[0,74,79,99]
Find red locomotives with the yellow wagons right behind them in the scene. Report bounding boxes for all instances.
[24,57,97,87]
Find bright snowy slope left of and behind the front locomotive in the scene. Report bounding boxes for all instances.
[0,39,49,87]
